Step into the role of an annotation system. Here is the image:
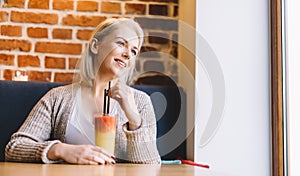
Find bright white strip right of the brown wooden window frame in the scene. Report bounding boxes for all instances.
[286,0,300,176]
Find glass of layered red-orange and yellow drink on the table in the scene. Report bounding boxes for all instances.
[95,115,116,154]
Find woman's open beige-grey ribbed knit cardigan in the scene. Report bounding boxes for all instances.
[5,83,161,164]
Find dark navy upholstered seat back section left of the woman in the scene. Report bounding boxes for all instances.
[0,81,62,161]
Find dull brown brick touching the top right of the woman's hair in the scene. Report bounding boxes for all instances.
[135,17,178,31]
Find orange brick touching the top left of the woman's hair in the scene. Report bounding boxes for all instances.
[62,15,106,27]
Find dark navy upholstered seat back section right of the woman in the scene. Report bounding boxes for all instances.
[132,85,187,160]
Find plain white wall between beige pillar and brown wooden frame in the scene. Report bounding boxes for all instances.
[195,0,270,176]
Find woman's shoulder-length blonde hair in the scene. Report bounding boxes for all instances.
[79,18,144,86]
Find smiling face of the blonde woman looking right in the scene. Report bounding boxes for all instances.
[94,27,139,79]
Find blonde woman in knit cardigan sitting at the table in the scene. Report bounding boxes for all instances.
[5,18,160,164]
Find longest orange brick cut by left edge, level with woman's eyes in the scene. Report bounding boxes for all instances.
[0,39,31,52]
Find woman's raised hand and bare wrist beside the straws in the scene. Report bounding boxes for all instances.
[108,82,142,130]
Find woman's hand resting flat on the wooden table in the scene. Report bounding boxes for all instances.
[47,143,116,164]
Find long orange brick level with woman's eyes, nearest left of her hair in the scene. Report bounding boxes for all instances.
[35,42,81,54]
